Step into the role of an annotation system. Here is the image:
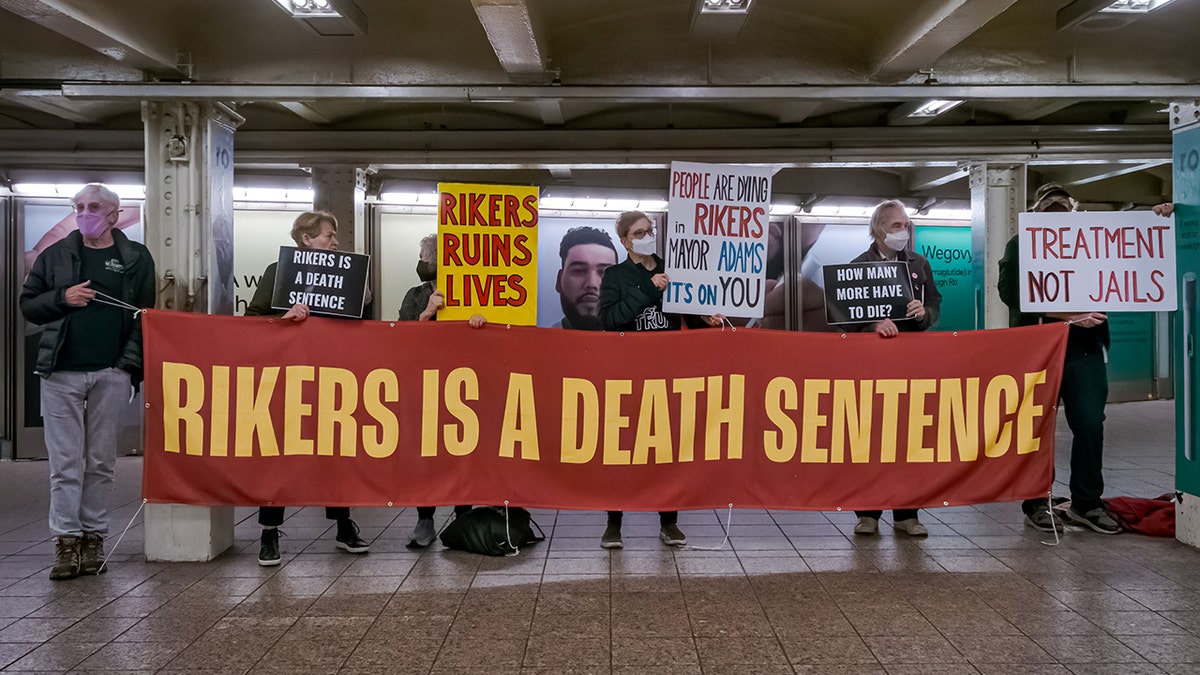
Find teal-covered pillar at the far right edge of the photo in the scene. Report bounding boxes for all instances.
[1170,100,1200,546]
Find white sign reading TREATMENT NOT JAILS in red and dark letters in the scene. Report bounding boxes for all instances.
[1018,211,1177,312]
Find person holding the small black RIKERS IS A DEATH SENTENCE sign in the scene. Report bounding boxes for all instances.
[246,211,371,567]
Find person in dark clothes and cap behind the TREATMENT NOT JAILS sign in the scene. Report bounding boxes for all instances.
[996,183,1121,534]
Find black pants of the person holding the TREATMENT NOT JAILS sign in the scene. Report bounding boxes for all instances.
[1021,350,1109,514]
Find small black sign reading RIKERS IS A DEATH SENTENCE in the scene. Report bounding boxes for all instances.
[271,246,371,318]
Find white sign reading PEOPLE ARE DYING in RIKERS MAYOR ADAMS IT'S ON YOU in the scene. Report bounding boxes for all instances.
[662,162,773,318]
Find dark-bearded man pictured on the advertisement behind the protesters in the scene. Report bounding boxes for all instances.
[554,226,617,330]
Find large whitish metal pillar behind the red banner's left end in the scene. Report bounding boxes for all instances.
[142,101,244,561]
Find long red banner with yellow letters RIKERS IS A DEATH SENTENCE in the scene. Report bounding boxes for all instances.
[143,311,1067,510]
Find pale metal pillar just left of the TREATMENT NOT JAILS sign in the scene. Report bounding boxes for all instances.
[970,163,1026,328]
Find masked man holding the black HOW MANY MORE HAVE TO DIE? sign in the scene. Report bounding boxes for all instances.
[852,199,942,537]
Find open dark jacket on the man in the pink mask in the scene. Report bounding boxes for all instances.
[20,228,156,382]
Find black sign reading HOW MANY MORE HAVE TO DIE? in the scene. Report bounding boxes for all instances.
[821,261,912,323]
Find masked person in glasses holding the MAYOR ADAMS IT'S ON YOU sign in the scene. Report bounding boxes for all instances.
[600,211,725,549]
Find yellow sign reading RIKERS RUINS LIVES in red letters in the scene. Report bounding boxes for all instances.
[437,183,538,325]
